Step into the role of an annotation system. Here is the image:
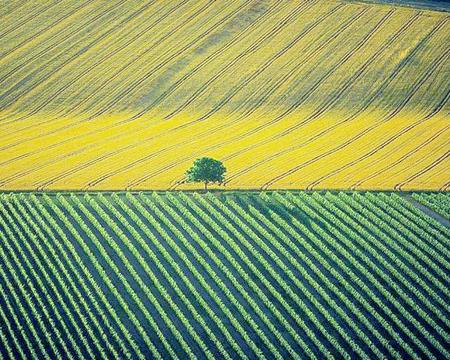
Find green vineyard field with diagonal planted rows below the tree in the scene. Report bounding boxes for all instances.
[0,192,450,360]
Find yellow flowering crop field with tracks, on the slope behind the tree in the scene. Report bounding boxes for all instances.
[0,0,450,190]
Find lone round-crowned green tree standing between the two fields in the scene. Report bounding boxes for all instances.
[186,157,227,190]
